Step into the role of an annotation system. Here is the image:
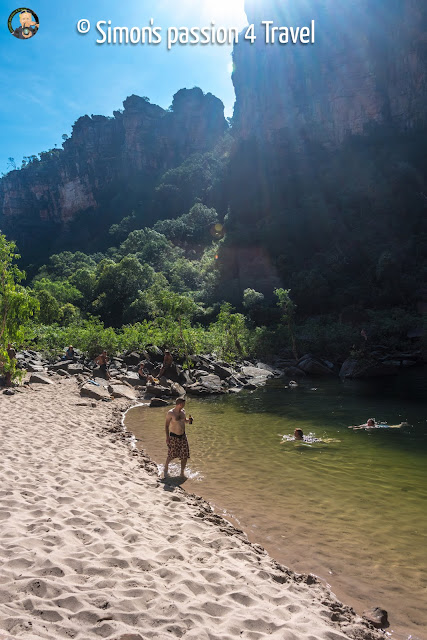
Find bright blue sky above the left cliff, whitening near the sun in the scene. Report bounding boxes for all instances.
[0,0,247,174]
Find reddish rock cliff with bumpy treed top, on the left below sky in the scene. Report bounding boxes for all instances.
[0,88,228,260]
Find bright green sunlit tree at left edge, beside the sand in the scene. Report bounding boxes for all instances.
[0,234,38,383]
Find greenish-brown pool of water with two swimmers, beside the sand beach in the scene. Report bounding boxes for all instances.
[126,370,427,640]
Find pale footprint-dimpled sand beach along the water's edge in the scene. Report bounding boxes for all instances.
[0,379,383,640]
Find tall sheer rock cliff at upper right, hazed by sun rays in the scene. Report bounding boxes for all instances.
[233,0,427,146]
